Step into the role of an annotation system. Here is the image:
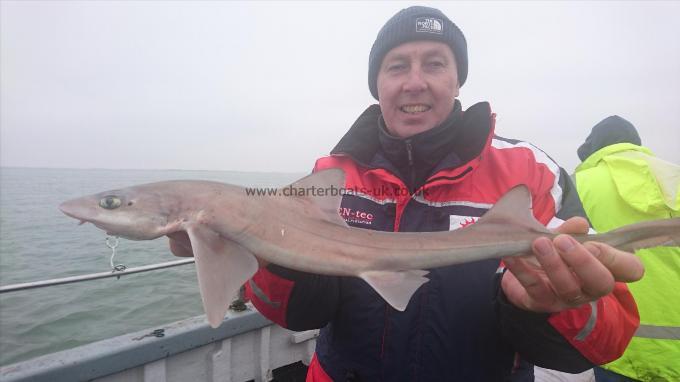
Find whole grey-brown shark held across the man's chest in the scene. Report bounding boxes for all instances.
[59,169,680,327]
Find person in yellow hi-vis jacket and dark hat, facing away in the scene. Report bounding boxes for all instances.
[575,116,680,382]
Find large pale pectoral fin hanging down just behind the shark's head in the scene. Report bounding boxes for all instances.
[187,225,258,328]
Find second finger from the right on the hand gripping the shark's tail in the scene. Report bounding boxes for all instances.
[553,235,614,301]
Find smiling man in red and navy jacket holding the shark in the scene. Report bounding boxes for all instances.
[171,7,643,381]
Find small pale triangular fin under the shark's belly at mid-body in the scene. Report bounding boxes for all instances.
[359,269,429,312]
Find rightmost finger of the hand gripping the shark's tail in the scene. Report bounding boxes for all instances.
[584,241,645,283]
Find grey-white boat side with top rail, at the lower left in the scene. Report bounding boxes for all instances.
[0,304,318,382]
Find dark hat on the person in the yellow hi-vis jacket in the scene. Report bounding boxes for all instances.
[576,115,642,161]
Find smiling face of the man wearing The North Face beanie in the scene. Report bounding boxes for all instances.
[378,41,459,138]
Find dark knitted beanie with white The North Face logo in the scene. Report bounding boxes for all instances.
[368,6,468,99]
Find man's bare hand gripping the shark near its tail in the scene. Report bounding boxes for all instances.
[501,218,644,312]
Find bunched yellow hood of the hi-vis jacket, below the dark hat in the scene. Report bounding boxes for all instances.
[576,143,680,224]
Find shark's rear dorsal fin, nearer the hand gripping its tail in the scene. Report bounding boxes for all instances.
[473,184,550,232]
